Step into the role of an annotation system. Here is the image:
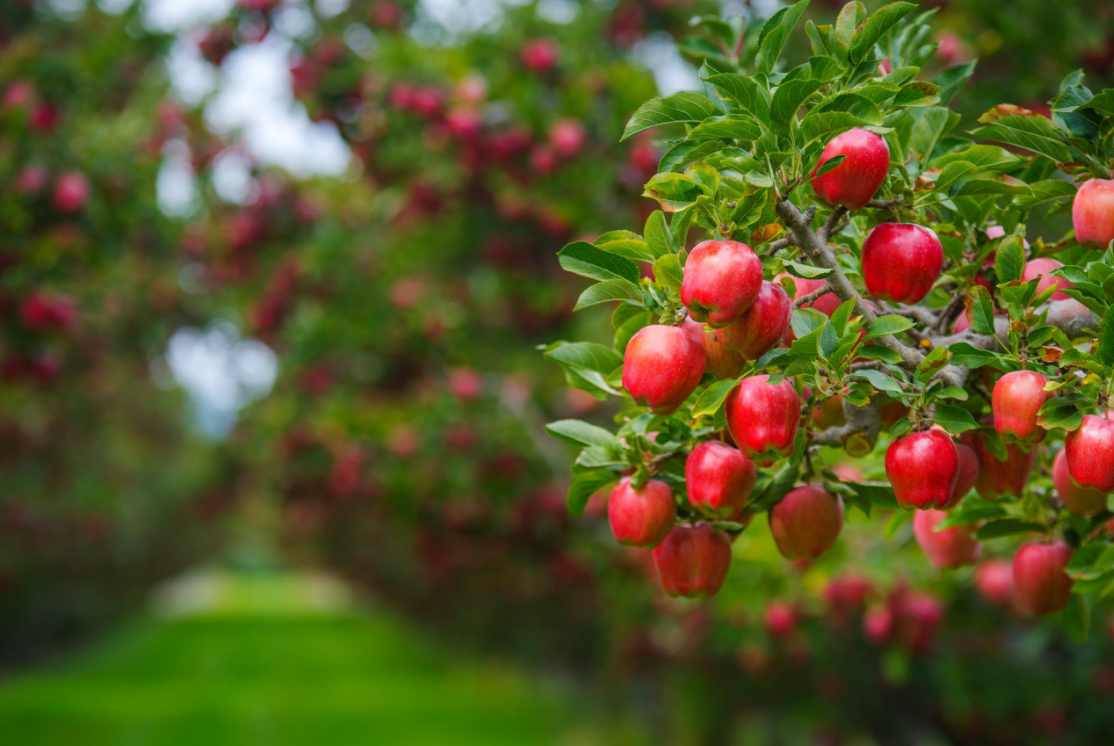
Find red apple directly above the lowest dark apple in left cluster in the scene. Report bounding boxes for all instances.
[685,440,758,518]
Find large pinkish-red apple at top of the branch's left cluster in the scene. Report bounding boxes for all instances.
[681,241,762,326]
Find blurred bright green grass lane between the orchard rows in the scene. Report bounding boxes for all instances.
[0,576,628,746]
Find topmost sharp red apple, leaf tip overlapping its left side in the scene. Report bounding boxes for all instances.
[812,128,890,209]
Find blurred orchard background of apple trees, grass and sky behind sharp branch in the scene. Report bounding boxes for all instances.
[0,0,1114,745]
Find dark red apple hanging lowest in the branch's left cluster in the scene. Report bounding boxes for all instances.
[654,523,731,598]
